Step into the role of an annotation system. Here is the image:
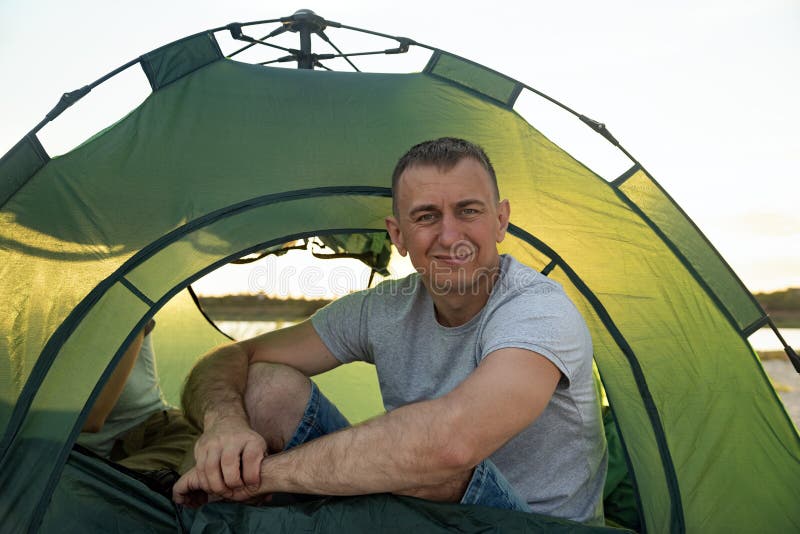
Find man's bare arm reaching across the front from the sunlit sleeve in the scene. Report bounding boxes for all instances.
[173,349,560,503]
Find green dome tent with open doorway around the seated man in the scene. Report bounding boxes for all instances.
[0,9,800,532]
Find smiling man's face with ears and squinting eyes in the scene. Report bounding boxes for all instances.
[386,158,509,294]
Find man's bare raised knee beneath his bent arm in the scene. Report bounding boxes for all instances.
[244,362,311,452]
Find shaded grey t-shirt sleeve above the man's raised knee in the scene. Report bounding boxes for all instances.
[311,291,374,363]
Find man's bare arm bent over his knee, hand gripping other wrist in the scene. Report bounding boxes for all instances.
[181,321,339,496]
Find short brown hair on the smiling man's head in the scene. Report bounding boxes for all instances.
[392,137,500,216]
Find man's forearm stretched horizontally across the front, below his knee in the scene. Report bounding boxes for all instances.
[253,400,472,495]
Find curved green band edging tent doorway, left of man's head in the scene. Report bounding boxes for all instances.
[3,193,400,532]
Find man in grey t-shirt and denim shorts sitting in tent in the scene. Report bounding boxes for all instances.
[173,138,606,523]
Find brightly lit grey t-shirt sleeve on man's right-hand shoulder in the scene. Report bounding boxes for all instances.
[480,286,592,388]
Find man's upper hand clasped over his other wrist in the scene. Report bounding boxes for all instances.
[192,416,267,502]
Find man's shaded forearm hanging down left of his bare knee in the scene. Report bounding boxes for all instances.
[181,345,248,429]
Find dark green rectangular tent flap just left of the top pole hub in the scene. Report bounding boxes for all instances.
[141,32,223,91]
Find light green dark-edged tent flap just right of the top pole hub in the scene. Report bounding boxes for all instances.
[423,50,523,108]
